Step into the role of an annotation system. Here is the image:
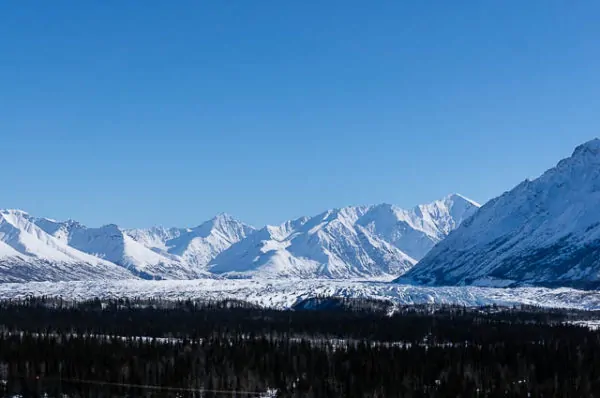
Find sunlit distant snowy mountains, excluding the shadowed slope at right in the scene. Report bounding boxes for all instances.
[0,194,479,282]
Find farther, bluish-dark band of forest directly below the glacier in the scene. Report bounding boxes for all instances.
[0,298,600,342]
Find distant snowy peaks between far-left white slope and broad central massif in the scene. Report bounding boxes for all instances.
[33,215,253,279]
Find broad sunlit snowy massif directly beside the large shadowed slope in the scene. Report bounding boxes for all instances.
[210,194,479,278]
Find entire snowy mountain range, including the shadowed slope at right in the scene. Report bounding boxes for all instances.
[0,139,600,289]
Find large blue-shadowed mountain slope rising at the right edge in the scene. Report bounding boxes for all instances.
[400,139,600,288]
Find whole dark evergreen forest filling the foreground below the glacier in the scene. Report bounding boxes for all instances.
[0,298,600,397]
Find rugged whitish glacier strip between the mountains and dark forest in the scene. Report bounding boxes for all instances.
[0,279,600,310]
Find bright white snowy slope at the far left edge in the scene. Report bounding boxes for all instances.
[0,210,134,282]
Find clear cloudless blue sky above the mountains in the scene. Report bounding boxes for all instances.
[0,0,600,227]
